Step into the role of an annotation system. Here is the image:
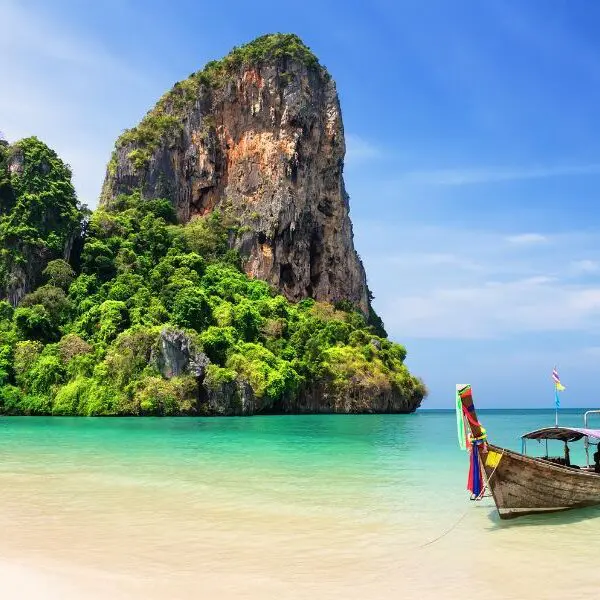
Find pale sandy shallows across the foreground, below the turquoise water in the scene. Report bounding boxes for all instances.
[0,450,600,600]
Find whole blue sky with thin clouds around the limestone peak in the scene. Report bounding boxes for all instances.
[0,0,600,407]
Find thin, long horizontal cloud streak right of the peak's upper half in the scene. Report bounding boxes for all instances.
[400,163,600,186]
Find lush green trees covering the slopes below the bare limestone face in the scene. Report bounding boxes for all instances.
[0,139,425,415]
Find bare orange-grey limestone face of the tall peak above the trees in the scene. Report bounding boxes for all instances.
[101,35,369,313]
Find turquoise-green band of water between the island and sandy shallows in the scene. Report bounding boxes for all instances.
[0,409,600,500]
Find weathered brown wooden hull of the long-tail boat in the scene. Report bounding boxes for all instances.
[480,444,600,519]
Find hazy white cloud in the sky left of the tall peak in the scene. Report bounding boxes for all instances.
[0,0,155,206]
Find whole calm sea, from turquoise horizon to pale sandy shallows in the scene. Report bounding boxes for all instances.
[0,409,600,600]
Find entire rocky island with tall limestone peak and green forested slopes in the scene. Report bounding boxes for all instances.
[0,34,426,416]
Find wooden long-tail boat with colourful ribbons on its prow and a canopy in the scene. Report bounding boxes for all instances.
[456,385,600,519]
